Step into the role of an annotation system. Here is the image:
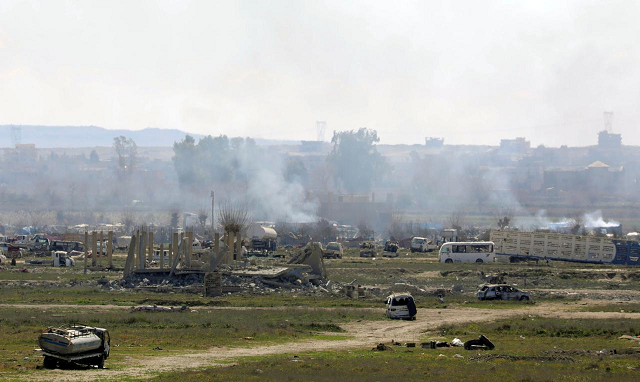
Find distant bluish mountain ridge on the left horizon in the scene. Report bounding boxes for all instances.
[0,125,298,148]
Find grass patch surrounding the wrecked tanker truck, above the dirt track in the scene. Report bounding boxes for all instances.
[0,307,382,374]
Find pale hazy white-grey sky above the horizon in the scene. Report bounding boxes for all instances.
[0,0,640,146]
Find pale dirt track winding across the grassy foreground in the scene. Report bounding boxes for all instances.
[8,304,640,381]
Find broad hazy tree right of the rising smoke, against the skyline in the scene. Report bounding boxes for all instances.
[327,128,390,193]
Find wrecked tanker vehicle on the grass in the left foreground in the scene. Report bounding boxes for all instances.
[38,324,111,369]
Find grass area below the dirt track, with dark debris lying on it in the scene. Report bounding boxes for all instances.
[153,317,640,382]
